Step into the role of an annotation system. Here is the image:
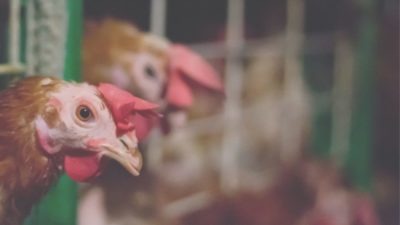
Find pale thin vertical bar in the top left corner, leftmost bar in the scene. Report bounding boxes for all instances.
[9,0,20,65]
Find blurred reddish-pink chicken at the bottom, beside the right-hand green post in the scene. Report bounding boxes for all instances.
[298,160,380,225]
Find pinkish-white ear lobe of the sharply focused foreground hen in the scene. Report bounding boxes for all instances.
[35,116,61,154]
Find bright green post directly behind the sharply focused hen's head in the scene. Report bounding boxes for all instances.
[25,0,83,225]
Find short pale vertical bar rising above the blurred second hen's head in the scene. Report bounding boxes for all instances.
[150,0,167,36]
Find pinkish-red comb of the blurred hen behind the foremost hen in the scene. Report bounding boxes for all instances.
[166,44,224,107]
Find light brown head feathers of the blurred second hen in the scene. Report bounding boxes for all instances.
[82,19,168,94]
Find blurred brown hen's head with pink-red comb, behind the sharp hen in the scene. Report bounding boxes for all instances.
[82,19,223,133]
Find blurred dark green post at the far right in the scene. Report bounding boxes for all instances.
[346,0,377,191]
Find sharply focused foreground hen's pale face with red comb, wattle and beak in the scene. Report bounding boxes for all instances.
[34,78,157,181]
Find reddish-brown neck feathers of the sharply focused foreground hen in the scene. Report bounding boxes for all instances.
[0,77,62,224]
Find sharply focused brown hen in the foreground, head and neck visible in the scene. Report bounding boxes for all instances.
[0,76,158,225]
